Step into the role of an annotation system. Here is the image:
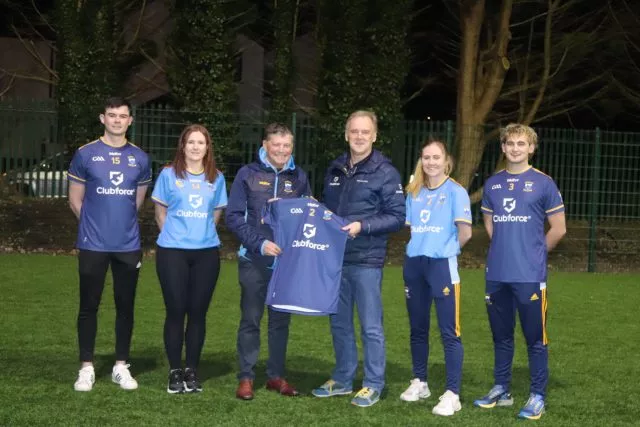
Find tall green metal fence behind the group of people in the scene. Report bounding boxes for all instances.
[0,102,640,271]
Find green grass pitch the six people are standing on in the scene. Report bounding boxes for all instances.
[0,254,640,426]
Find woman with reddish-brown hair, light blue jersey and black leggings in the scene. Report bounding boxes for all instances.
[152,124,227,394]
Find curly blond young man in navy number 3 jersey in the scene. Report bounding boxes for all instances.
[474,123,566,420]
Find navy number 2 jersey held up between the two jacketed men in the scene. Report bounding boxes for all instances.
[262,198,348,316]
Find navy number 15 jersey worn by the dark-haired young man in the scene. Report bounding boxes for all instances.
[68,139,151,252]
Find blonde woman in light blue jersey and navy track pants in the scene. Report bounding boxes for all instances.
[400,140,471,416]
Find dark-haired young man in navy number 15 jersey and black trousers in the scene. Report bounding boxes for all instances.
[68,98,151,391]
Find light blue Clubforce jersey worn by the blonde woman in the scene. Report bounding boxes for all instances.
[406,177,471,258]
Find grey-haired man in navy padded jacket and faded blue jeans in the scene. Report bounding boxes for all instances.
[312,111,405,407]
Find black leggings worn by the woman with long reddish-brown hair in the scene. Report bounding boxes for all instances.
[156,247,220,369]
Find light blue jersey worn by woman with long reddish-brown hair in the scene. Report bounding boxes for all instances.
[151,167,227,249]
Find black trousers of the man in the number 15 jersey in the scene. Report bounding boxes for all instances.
[78,250,142,362]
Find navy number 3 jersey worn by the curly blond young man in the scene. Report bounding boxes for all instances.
[482,168,564,283]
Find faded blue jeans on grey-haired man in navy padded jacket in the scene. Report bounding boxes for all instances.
[330,265,386,392]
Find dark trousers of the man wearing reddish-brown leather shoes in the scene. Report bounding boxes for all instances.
[237,258,291,379]
